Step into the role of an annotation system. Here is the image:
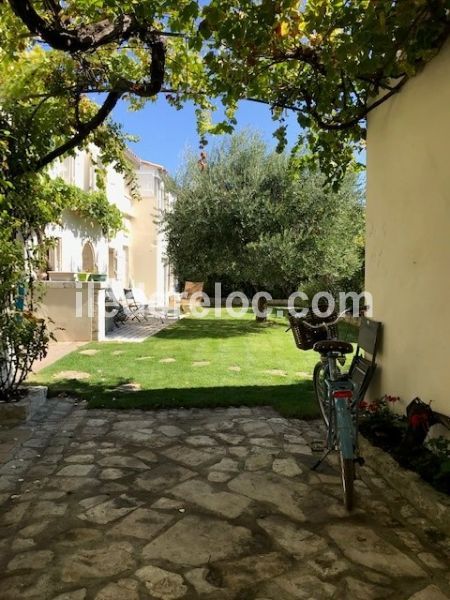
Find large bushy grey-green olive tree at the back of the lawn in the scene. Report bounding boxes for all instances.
[163,132,363,318]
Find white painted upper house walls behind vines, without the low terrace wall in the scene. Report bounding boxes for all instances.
[48,147,174,305]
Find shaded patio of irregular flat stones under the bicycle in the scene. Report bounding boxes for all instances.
[0,399,450,600]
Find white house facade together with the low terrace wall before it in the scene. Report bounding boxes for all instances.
[43,148,174,341]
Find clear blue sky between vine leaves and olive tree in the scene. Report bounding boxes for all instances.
[113,96,299,174]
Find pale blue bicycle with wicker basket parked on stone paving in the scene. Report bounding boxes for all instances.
[289,310,364,511]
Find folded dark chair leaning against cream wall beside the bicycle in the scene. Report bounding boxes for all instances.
[349,317,381,402]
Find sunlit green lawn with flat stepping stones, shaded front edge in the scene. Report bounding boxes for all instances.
[29,311,358,418]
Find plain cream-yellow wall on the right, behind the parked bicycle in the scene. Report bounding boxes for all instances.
[366,44,450,414]
